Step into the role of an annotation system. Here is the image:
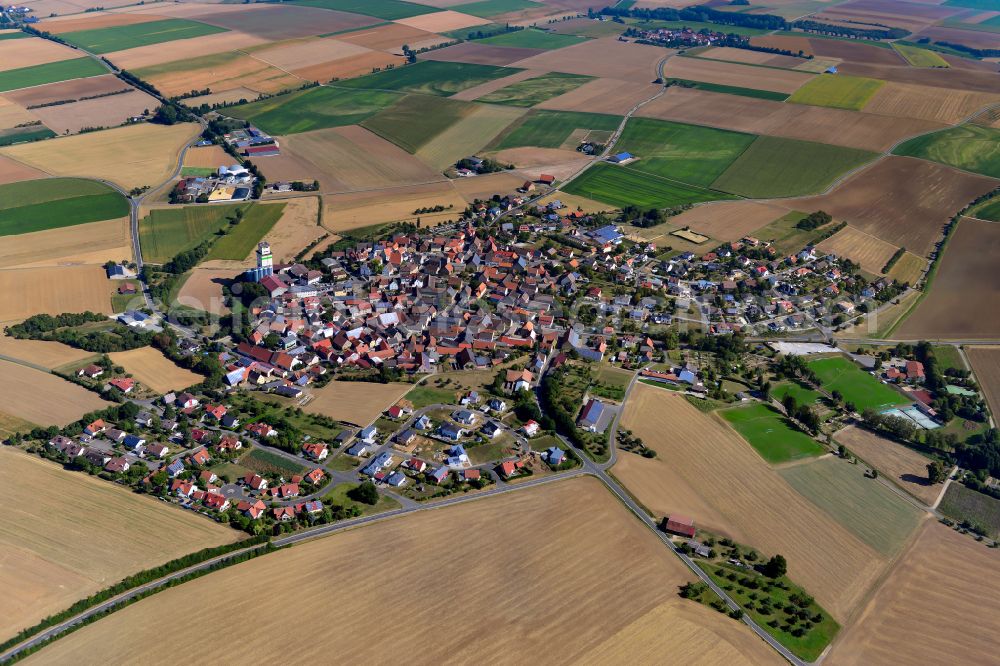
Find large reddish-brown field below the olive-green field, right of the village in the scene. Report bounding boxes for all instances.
[787,156,997,256]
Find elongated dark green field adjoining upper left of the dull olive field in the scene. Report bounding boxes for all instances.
[226,87,400,135]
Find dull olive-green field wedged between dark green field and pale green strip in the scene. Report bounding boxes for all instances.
[361,95,476,153]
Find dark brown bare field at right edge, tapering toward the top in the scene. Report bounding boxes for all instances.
[894,218,1000,340]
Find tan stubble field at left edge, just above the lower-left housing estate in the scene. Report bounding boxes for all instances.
[0,361,114,426]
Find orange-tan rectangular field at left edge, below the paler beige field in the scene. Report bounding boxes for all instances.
[0,266,111,322]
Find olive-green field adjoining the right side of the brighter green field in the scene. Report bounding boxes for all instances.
[712,136,876,199]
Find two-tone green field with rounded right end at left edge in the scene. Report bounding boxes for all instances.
[0,178,129,236]
